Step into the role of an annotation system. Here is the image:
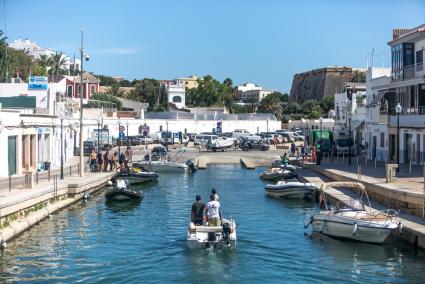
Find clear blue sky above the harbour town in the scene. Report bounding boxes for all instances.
[0,0,425,92]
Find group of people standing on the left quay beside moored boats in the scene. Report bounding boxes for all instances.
[88,146,133,172]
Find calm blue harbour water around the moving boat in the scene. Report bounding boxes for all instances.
[0,165,425,283]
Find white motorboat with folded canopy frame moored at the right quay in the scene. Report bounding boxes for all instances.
[305,182,402,244]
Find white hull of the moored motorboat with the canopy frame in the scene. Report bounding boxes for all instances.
[312,214,399,244]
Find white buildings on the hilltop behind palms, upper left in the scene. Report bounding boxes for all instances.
[8,38,81,70]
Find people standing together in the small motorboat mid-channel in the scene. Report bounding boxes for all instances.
[190,189,221,227]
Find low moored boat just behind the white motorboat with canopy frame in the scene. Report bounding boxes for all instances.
[265,181,317,198]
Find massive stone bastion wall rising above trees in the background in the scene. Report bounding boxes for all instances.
[289,67,353,103]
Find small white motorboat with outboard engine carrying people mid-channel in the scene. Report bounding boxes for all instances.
[187,218,237,249]
